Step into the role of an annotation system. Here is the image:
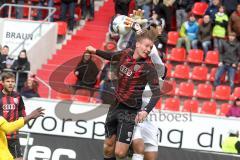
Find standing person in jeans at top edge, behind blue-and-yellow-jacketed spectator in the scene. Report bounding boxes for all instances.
[175,0,194,31]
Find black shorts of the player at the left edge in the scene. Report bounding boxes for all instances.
[8,139,23,158]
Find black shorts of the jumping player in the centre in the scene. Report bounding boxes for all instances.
[105,103,138,144]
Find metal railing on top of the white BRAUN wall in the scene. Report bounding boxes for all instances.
[0,3,56,56]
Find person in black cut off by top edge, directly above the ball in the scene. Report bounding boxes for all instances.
[114,0,131,16]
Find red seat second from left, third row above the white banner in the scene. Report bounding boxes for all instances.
[173,65,190,79]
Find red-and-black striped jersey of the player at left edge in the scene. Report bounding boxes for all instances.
[0,91,26,139]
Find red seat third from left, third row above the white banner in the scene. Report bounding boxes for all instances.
[191,66,208,81]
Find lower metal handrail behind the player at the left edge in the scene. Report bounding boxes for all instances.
[3,69,52,99]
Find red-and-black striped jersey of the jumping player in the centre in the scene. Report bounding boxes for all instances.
[96,49,160,113]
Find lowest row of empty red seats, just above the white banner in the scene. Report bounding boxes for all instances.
[161,98,231,116]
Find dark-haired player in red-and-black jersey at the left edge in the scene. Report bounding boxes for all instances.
[0,72,26,160]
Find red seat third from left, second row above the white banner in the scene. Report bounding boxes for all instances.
[196,84,212,99]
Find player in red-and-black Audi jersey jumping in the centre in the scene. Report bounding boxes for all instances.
[86,26,160,160]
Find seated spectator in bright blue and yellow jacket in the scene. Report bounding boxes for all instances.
[177,13,199,52]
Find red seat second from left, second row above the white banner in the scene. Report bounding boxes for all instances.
[178,82,194,97]
